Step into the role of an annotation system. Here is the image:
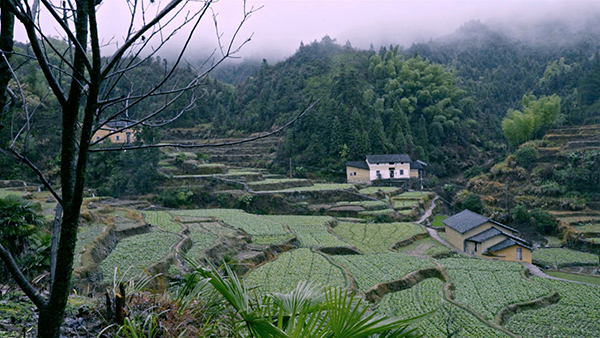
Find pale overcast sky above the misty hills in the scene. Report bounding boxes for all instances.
[17,0,600,61]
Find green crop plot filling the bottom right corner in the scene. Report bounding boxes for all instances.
[506,277,600,338]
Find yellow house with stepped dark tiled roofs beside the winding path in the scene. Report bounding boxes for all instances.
[442,210,531,263]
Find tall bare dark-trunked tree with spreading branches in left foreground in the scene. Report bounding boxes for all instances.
[0,0,318,338]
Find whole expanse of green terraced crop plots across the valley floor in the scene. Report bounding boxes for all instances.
[45,201,600,338]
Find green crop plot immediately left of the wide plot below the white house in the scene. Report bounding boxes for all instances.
[262,216,349,248]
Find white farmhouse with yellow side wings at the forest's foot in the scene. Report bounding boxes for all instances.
[346,154,427,184]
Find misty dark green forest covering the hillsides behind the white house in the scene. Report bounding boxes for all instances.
[0,17,600,187]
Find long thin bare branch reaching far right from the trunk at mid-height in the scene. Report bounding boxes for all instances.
[90,95,324,153]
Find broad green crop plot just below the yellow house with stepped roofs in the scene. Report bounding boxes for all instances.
[440,258,550,320]
